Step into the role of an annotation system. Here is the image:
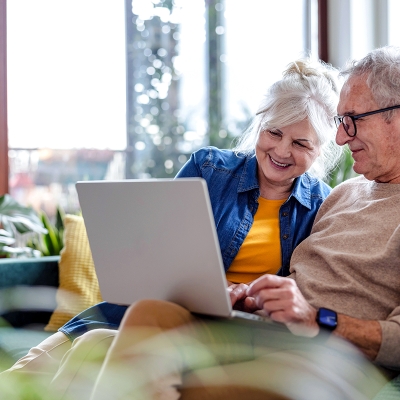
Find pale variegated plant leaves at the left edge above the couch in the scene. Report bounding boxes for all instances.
[0,194,47,257]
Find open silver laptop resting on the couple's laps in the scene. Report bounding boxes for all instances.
[76,178,276,320]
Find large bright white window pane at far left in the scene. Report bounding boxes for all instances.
[7,0,126,150]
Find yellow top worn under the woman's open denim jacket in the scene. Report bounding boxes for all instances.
[226,197,286,283]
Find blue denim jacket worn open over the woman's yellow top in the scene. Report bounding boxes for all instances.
[176,147,331,276]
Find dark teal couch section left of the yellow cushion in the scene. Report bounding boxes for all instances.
[0,256,60,368]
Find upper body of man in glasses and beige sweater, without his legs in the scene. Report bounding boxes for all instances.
[248,44,400,362]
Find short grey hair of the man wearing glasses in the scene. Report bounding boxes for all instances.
[340,46,400,121]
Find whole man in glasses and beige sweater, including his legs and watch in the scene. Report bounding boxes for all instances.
[82,47,400,399]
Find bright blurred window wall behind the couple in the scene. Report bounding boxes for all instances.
[0,0,400,218]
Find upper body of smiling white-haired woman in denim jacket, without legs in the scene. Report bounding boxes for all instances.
[177,61,340,283]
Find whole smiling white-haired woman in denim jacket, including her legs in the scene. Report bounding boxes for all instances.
[3,59,340,398]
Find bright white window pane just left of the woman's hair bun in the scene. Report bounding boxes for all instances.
[223,0,306,122]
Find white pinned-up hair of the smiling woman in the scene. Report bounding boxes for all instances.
[233,58,342,179]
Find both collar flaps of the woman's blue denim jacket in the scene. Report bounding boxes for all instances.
[238,152,312,209]
